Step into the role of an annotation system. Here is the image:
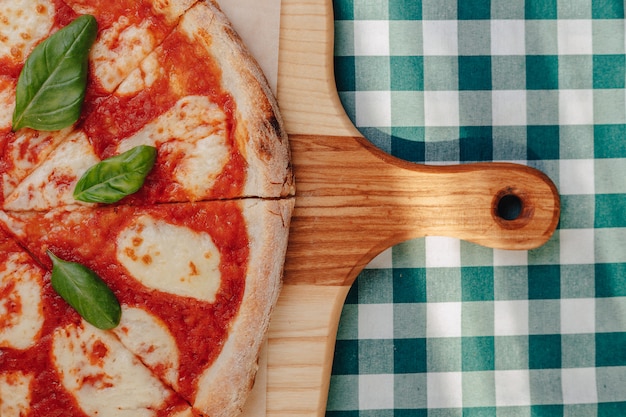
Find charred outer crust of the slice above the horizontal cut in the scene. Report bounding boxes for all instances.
[178,1,295,198]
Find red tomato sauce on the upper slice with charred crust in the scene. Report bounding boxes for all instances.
[82,28,246,204]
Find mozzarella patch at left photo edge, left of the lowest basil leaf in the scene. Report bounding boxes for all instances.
[0,253,43,350]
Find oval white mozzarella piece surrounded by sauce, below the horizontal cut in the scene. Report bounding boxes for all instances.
[117,215,221,303]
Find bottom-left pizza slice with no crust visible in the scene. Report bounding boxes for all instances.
[0,228,194,417]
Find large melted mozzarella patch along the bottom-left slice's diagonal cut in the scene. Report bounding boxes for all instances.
[52,323,169,417]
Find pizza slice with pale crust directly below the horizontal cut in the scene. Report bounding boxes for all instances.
[0,199,293,417]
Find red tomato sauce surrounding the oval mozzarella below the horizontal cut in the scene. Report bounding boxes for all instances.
[7,202,249,399]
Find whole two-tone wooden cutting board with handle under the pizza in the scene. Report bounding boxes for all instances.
[266,0,559,417]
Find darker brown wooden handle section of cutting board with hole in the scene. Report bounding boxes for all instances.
[285,135,560,285]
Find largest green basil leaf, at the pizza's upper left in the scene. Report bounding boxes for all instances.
[13,15,98,131]
